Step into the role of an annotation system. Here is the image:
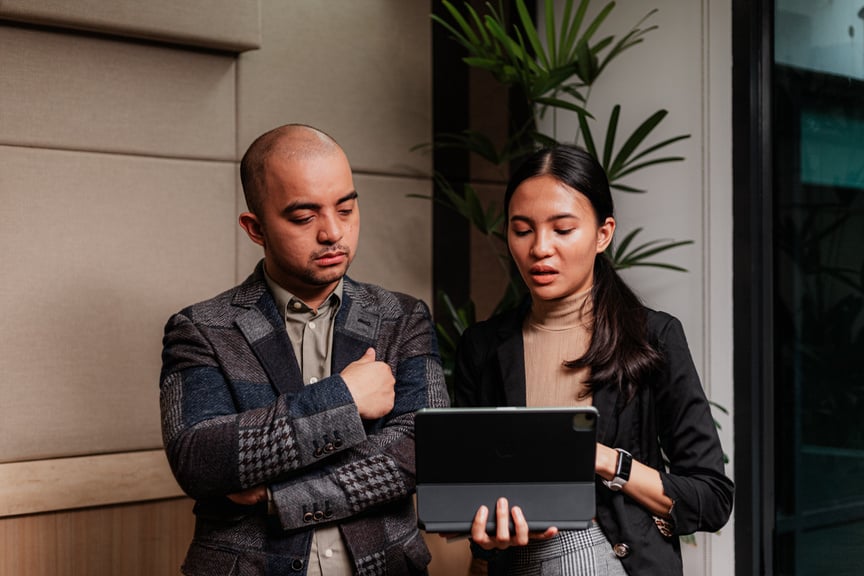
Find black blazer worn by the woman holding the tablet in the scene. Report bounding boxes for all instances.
[454,305,734,576]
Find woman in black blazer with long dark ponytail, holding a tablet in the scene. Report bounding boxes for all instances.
[455,146,733,576]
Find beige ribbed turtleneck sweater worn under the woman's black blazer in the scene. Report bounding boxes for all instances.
[522,289,591,406]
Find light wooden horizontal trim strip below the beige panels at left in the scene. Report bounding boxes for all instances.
[0,450,183,517]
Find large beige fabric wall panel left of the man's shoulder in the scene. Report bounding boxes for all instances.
[0,146,235,461]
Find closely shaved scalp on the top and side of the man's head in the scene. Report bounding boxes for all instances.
[240,124,344,214]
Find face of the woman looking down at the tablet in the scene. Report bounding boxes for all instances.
[507,175,615,300]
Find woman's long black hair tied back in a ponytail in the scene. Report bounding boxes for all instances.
[504,145,662,397]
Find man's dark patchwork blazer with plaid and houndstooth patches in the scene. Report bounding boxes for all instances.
[160,263,448,576]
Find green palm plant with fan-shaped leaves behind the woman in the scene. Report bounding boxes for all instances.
[416,0,692,382]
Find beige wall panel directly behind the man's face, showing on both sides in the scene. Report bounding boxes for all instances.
[235,174,432,306]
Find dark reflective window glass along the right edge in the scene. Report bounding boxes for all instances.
[772,0,864,576]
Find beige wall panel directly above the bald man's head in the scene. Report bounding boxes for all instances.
[238,0,432,174]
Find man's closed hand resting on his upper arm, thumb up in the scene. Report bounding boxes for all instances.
[340,348,396,420]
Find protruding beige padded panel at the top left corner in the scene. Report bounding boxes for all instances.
[0,0,261,51]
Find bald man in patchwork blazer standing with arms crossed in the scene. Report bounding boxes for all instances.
[160,125,448,576]
